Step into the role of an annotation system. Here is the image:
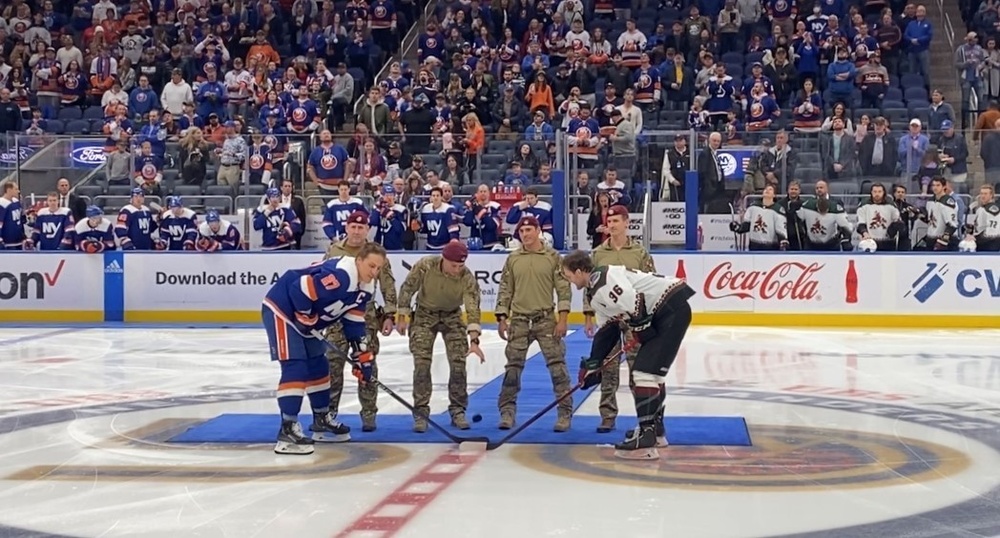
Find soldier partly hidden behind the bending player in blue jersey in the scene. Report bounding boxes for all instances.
[323,207,396,432]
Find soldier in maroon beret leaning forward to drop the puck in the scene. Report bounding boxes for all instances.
[396,242,484,433]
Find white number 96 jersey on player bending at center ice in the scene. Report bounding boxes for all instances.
[587,265,690,327]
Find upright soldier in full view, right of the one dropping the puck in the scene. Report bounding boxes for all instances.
[496,216,573,432]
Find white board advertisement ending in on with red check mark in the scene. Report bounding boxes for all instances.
[0,252,104,311]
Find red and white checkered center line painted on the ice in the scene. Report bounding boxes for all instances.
[336,452,482,538]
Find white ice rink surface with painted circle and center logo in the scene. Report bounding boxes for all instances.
[0,327,1000,538]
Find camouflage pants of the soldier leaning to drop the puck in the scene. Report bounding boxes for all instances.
[410,310,469,416]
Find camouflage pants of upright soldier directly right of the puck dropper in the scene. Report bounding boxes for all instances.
[498,314,573,415]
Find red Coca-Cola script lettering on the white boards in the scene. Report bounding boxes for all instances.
[703,262,824,301]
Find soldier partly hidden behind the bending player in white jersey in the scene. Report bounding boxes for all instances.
[583,205,656,433]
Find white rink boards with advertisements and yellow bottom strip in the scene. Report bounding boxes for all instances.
[0,251,1000,328]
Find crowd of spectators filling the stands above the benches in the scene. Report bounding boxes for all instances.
[0,0,1000,251]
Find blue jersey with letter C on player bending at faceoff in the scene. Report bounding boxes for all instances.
[264,256,375,342]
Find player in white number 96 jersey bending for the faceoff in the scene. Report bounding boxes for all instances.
[562,250,694,459]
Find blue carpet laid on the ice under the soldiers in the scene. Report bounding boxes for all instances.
[169,331,751,446]
